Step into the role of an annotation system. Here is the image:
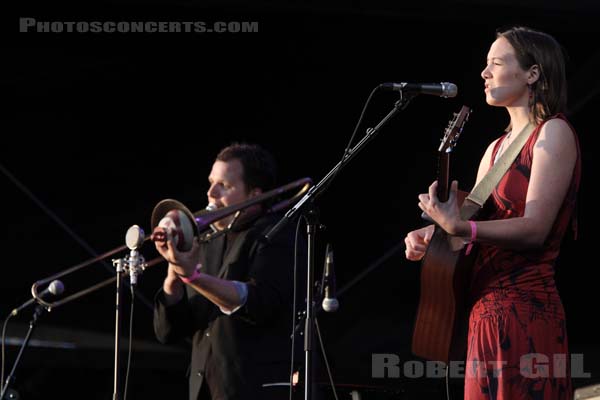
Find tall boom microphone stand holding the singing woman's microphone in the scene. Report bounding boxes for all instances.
[263,91,416,400]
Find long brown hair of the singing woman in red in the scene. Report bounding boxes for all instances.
[496,26,567,123]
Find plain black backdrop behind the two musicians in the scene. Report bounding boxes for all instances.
[0,0,600,399]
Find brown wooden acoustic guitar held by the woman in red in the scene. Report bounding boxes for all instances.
[412,106,475,364]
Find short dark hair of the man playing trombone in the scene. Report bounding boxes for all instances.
[217,143,277,192]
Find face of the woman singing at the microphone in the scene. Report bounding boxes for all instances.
[481,37,533,107]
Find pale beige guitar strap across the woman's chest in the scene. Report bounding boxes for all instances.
[461,122,535,219]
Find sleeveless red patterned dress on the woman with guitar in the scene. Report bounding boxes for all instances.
[465,115,581,400]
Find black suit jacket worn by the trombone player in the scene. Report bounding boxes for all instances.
[154,211,306,400]
